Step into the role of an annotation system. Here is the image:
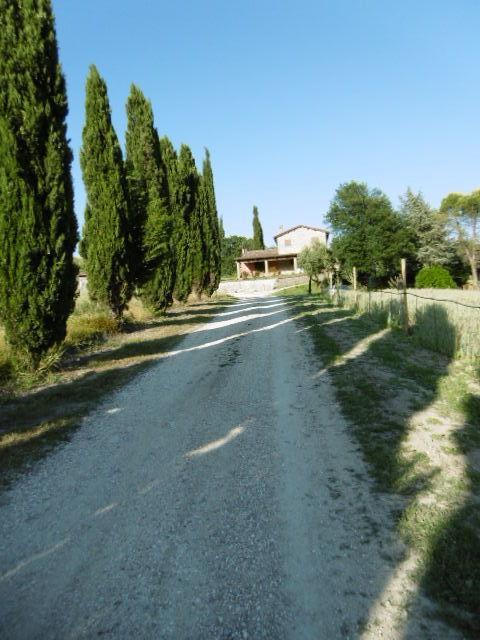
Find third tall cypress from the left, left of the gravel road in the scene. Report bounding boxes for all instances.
[126,85,173,310]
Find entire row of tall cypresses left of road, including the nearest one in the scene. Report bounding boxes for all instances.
[0,0,221,367]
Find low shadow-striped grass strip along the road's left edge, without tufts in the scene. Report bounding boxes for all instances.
[0,302,229,487]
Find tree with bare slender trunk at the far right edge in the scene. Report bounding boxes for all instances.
[440,189,480,288]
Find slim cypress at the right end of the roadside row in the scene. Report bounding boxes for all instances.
[201,149,221,295]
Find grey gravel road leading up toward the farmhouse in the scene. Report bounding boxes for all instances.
[0,298,442,640]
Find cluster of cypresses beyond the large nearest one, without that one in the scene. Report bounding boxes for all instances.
[81,66,221,318]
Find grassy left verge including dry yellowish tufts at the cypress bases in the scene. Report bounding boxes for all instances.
[0,292,229,486]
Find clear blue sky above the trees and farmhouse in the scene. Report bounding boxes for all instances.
[53,0,480,244]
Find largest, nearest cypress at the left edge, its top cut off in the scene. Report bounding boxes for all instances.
[0,0,77,366]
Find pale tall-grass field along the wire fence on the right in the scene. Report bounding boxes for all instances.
[336,289,480,359]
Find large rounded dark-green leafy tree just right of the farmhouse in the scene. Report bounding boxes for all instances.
[327,181,414,284]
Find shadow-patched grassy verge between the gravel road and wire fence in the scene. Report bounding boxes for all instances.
[283,287,480,637]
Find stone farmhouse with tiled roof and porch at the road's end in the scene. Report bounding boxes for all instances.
[236,224,329,279]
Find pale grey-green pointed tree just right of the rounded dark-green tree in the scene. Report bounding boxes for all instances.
[400,189,453,266]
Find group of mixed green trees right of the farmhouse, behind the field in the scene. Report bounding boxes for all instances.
[299,181,480,288]
